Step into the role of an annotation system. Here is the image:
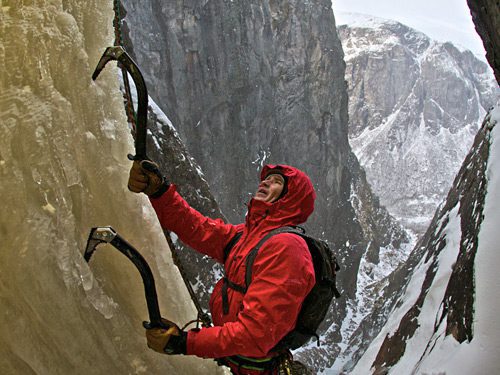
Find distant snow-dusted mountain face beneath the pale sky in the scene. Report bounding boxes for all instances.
[338,15,500,234]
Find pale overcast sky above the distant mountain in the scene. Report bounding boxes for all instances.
[332,0,486,61]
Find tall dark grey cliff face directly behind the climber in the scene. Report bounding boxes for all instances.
[122,0,407,366]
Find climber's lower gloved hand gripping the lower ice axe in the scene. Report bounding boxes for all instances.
[146,318,187,354]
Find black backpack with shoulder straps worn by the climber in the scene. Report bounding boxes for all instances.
[222,227,340,351]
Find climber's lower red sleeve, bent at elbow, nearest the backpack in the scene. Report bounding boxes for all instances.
[187,233,315,358]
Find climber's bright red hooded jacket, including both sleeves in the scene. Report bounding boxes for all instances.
[151,165,316,358]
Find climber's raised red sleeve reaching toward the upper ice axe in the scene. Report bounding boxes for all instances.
[150,184,237,263]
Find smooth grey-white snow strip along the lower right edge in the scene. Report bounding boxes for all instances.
[418,107,500,374]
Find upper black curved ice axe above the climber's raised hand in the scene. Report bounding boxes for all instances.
[92,46,148,160]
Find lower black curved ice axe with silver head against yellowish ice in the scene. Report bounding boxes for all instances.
[83,227,169,329]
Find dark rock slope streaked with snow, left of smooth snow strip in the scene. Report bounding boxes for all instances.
[344,110,494,374]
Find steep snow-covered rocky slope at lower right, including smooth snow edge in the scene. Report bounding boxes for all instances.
[344,107,500,375]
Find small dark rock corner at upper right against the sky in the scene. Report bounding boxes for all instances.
[467,0,500,82]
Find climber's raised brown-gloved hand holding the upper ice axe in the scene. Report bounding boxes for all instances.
[128,160,169,197]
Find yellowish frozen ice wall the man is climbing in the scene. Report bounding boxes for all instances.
[0,0,220,374]
